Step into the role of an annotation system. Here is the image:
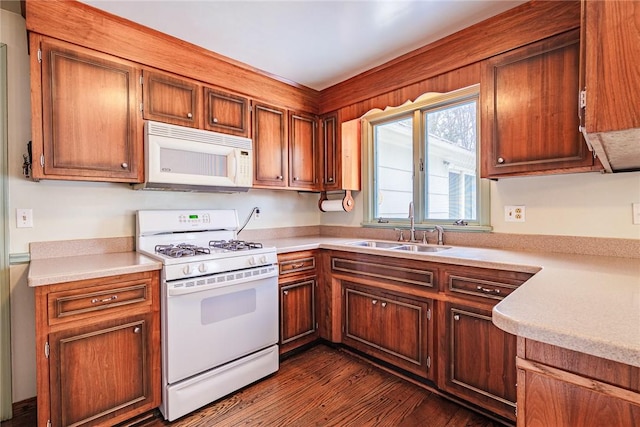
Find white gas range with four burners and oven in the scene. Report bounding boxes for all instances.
[136,210,279,421]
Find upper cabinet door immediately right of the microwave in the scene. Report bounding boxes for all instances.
[253,104,288,187]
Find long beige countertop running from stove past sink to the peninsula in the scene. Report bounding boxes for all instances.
[263,236,640,367]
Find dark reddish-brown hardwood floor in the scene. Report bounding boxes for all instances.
[2,345,500,427]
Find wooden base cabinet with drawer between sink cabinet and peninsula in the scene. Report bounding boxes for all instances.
[438,266,531,420]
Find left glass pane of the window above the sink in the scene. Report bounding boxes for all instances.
[373,117,413,218]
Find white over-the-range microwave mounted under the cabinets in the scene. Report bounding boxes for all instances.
[133,121,253,192]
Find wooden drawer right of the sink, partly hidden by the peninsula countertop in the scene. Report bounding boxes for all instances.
[445,269,532,300]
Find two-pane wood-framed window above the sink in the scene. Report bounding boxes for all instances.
[363,85,489,229]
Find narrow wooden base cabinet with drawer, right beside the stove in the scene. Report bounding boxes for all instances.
[278,251,318,354]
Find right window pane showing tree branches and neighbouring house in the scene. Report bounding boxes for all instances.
[425,100,477,220]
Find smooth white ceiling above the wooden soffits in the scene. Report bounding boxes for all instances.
[82,0,525,90]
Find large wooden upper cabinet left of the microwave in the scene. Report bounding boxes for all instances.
[29,33,144,182]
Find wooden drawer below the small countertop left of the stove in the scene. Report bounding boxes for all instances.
[48,280,151,324]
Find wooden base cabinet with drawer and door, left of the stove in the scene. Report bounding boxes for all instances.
[35,271,161,427]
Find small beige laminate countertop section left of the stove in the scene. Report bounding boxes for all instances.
[27,252,162,287]
